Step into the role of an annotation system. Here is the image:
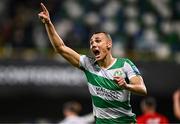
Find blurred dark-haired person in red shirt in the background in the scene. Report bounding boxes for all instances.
[137,97,169,124]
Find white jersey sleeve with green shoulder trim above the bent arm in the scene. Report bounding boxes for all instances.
[123,59,141,79]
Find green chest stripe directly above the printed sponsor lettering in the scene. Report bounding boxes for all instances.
[84,70,123,91]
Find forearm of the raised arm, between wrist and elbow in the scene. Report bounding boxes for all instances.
[45,21,65,52]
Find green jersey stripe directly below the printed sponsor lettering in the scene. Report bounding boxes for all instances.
[91,95,131,110]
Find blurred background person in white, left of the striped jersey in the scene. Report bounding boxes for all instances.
[59,101,94,124]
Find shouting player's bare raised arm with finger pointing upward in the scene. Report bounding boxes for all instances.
[38,3,80,68]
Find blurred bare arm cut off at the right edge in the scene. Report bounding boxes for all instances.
[173,89,180,120]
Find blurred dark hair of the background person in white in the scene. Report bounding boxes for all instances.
[63,101,82,114]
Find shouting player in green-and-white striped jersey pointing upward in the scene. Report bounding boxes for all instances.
[39,3,147,124]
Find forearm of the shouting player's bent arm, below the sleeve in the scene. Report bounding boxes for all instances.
[125,84,147,95]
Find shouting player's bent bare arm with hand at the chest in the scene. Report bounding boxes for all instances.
[114,75,147,95]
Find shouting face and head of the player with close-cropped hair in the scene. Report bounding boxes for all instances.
[90,33,112,61]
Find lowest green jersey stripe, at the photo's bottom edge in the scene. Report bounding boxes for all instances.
[96,115,136,124]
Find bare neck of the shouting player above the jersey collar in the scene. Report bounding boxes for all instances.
[97,54,115,68]
